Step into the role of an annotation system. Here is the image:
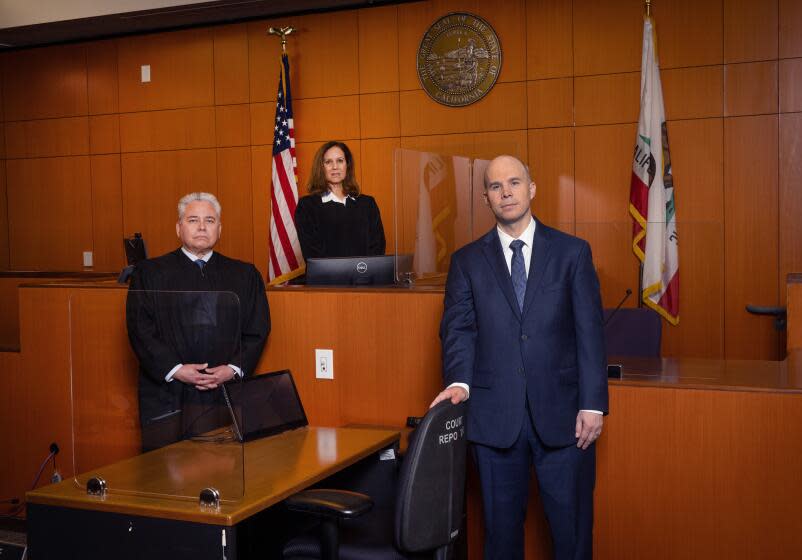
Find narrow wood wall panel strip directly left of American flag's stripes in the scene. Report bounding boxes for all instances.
[251,146,270,283]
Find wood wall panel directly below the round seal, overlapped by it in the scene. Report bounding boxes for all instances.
[401,82,526,136]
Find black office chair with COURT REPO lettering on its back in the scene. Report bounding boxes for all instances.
[284,401,467,560]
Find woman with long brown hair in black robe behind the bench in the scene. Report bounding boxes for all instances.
[295,141,385,259]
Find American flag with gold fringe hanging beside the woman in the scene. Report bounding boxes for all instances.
[269,54,304,284]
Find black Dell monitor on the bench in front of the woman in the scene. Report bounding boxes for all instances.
[306,255,412,286]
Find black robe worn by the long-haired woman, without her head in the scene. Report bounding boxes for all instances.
[295,194,385,259]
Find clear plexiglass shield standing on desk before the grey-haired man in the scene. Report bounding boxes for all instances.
[69,290,244,502]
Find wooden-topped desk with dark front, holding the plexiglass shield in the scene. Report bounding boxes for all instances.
[27,427,399,559]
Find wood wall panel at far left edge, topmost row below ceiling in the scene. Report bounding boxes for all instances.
[3,44,88,121]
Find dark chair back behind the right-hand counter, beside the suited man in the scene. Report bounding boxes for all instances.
[604,307,663,358]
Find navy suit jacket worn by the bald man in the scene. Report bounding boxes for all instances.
[440,217,608,448]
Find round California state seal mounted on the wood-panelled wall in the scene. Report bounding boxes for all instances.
[418,12,501,107]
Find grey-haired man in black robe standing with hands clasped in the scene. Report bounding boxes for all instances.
[126,193,270,451]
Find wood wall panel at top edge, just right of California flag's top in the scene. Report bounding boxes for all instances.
[656,0,724,69]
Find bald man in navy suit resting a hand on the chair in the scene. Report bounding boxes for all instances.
[432,156,607,560]
